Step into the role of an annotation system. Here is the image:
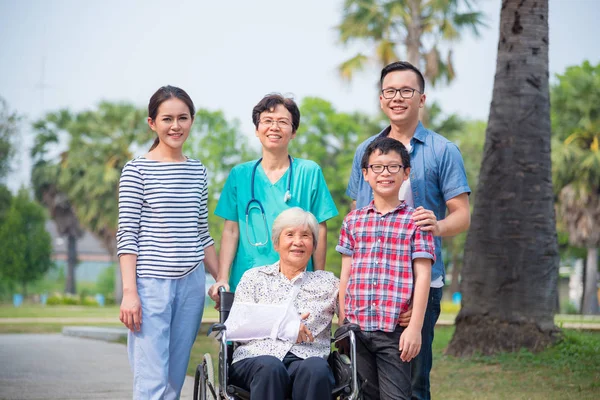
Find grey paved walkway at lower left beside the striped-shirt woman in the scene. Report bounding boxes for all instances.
[0,334,193,400]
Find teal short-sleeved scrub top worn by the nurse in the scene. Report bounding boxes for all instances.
[215,158,338,291]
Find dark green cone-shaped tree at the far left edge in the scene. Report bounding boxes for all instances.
[0,189,52,294]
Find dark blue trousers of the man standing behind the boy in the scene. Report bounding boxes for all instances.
[411,288,442,400]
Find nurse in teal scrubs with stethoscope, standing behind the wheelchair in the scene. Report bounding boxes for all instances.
[209,94,338,294]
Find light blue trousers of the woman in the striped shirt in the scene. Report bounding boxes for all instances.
[127,263,205,400]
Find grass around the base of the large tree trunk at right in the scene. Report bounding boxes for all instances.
[431,327,600,400]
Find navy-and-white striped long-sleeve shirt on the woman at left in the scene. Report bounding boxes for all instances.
[117,157,214,279]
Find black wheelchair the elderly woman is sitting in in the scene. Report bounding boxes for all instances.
[194,291,362,400]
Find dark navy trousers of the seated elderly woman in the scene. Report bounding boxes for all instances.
[229,353,335,400]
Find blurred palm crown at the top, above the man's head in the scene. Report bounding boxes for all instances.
[337,0,485,85]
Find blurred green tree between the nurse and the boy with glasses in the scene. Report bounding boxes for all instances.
[290,97,381,274]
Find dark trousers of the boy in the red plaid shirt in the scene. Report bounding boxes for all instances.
[356,326,411,400]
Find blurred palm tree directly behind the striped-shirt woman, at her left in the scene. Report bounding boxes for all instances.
[36,102,152,301]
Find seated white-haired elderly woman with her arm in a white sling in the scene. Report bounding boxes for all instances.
[225,207,339,400]
